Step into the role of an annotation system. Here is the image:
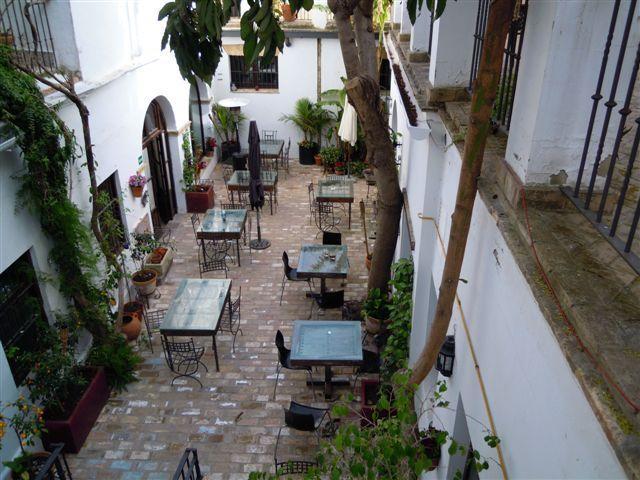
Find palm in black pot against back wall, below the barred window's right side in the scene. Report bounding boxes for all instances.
[280,98,333,165]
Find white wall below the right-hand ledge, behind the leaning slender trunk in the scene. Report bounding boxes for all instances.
[392,71,624,478]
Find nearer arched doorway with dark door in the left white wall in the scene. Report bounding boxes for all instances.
[142,100,178,229]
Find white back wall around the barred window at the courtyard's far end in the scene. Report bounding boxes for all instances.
[212,36,346,157]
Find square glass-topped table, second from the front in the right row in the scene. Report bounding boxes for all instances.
[298,243,349,293]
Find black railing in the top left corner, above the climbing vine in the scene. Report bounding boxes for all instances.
[0,0,57,71]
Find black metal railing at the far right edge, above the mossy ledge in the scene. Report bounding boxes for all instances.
[563,0,640,273]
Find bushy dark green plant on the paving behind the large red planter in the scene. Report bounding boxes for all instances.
[88,337,142,392]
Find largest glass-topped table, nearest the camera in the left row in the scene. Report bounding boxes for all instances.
[160,278,232,372]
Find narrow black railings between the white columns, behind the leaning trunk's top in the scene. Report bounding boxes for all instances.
[469,0,528,130]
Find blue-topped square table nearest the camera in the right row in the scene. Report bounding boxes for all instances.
[290,320,363,398]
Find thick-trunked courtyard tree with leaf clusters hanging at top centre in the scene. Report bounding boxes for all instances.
[159,0,402,291]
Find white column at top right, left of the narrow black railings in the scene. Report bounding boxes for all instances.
[429,0,478,88]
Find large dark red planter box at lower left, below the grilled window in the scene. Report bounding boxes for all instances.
[42,367,109,453]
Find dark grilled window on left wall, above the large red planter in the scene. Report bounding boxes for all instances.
[0,252,46,385]
